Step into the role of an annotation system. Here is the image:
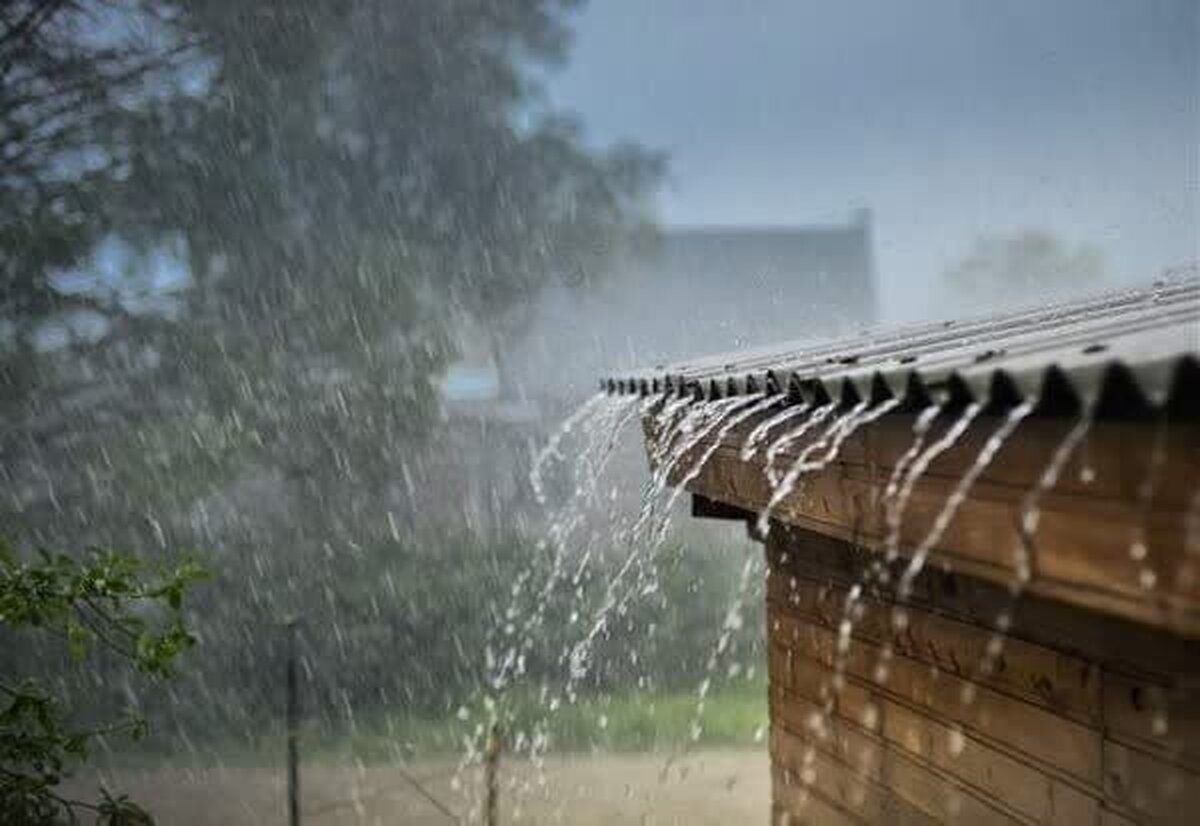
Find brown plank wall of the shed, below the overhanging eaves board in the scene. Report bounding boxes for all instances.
[767,523,1200,826]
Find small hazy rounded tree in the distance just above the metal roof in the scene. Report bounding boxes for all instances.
[946,229,1104,306]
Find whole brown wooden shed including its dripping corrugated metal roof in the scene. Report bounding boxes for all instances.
[604,279,1200,825]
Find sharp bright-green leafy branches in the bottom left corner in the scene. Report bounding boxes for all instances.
[0,544,203,826]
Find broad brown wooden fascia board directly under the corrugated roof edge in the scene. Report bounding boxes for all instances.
[662,417,1200,636]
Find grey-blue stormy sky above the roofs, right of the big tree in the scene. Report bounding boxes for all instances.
[548,0,1200,319]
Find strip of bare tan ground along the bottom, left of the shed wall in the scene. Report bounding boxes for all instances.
[77,750,770,826]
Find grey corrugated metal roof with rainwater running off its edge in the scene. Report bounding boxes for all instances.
[601,275,1200,415]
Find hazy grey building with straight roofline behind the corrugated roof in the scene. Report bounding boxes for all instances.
[512,210,876,396]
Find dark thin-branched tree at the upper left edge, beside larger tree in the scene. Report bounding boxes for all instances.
[0,0,191,394]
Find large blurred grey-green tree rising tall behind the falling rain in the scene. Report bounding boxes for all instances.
[0,0,661,744]
